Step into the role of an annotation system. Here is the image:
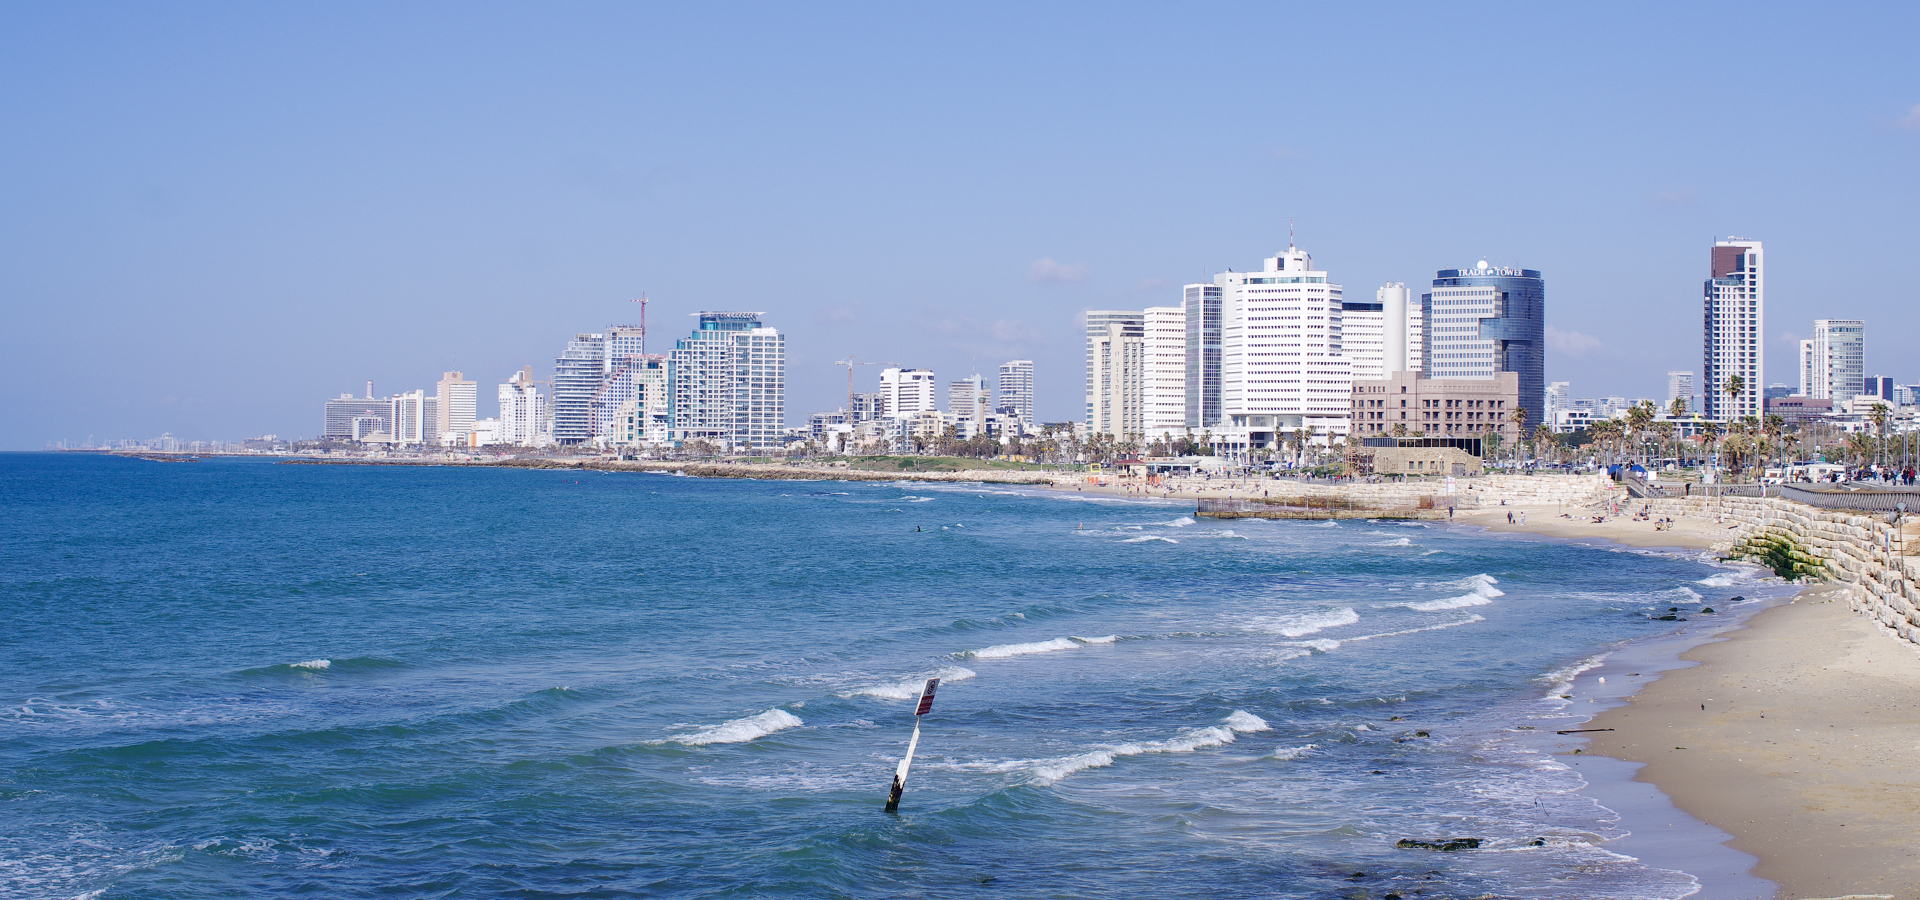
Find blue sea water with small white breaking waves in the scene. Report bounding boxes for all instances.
[0,455,1757,898]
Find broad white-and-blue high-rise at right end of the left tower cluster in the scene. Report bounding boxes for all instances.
[670,313,787,451]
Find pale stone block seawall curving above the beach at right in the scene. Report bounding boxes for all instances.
[1634,495,1920,645]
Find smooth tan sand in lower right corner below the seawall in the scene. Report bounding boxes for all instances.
[1586,587,1920,900]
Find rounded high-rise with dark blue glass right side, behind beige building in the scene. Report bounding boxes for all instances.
[1421,259,1548,422]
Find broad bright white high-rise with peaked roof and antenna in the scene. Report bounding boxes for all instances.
[1213,248,1354,434]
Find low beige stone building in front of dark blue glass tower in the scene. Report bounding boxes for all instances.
[1352,372,1538,443]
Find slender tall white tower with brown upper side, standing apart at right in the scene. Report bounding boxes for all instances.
[1699,238,1766,422]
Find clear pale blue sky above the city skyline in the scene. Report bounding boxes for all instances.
[0,2,1920,449]
